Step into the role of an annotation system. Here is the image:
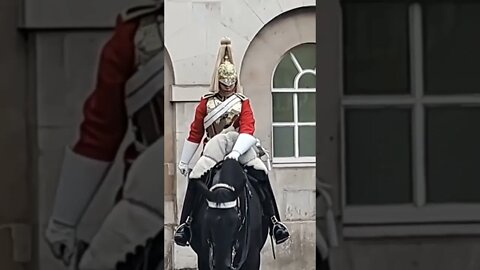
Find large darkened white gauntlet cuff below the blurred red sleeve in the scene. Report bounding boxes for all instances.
[52,147,111,227]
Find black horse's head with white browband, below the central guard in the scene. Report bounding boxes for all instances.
[196,159,247,270]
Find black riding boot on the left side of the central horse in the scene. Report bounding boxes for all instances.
[174,181,196,246]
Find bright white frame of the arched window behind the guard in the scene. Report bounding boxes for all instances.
[271,49,317,167]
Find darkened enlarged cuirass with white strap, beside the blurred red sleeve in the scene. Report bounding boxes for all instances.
[125,13,165,152]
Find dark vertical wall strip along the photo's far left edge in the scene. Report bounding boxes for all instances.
[0,0,33,270]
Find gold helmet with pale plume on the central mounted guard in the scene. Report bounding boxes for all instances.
[210,38,242,93]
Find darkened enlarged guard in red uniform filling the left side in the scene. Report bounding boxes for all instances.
[46,1,165,265]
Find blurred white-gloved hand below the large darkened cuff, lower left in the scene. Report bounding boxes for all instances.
[45,219,76,266]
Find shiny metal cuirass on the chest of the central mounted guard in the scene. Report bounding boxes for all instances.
[206,95,242,138]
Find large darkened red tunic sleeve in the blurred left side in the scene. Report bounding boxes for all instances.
[73,17,139,161]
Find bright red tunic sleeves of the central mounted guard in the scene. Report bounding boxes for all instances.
[187,98,255,143]
